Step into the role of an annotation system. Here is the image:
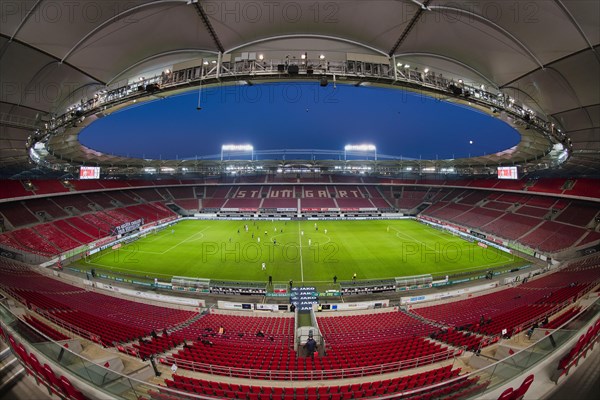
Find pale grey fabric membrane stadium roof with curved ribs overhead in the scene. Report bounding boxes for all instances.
[0,0,600,174]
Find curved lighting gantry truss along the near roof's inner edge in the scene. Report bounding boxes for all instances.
[30,56,566,167]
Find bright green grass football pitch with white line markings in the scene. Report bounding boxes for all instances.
[79,220,523,283]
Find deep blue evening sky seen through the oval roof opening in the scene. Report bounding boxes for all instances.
[79,81,520,159]
